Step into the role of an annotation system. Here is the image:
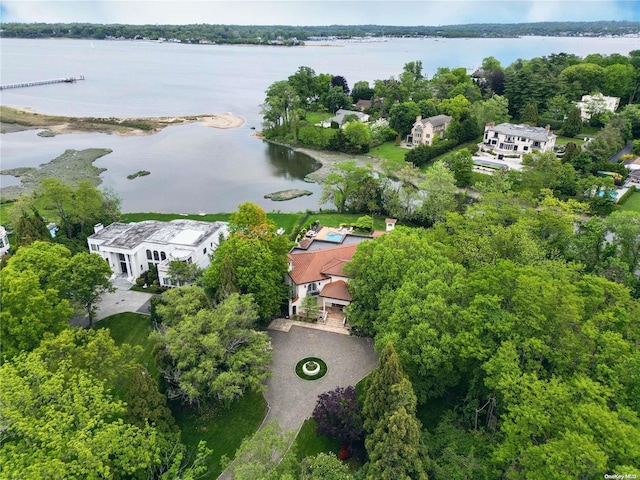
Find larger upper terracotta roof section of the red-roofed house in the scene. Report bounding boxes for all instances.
[289,244,358,285]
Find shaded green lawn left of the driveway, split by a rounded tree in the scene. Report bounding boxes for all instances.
[96,313,267,479]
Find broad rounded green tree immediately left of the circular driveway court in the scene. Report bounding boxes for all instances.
[153,287,271,405]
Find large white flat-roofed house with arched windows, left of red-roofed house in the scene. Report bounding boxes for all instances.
[87,219,229,286]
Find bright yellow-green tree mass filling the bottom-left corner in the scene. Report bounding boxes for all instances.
[0,330,169,479]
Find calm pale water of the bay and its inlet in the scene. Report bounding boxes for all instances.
[0,37,640,212]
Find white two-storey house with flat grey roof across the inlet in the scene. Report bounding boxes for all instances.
[478,122,557,159]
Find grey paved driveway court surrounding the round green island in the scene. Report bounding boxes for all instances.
[264,326,378,431]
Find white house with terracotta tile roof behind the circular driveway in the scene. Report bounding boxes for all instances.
[286,244,358,315]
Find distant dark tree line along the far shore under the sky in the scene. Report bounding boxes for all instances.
[1,21,640,44]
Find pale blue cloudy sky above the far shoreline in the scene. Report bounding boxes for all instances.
[0,0,640,26]
